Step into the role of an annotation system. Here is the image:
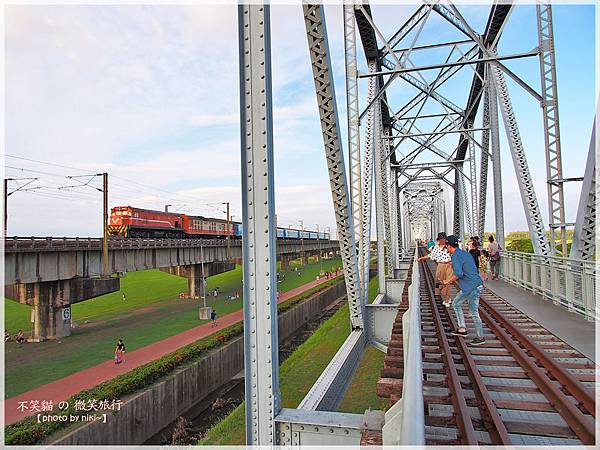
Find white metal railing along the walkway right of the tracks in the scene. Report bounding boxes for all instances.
[500,251,600,320]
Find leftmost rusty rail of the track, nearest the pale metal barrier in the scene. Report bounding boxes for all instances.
[421,255,479,445]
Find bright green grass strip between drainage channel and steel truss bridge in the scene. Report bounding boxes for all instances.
[199,304,350,445]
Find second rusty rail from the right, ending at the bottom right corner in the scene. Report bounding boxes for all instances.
[480,308,595,445]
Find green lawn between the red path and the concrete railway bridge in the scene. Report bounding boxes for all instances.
[5,258,341,398]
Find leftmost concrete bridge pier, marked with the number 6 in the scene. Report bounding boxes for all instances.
[5,278,120,342]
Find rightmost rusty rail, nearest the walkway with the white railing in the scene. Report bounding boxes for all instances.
[480,298,596,417]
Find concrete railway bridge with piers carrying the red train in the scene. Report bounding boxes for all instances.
[4,237,339,341]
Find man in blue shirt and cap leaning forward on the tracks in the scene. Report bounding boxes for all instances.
[444,235,485,345]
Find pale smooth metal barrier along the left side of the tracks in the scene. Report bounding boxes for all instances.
[383,251,425,445]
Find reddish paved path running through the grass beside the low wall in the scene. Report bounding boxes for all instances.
[4,278,340,425]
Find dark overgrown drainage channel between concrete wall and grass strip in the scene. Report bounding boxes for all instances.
[144,297,346,445]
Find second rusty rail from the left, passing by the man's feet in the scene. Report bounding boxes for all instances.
[421,250,512,445]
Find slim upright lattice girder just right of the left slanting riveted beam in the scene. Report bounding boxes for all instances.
[344,4,364,256]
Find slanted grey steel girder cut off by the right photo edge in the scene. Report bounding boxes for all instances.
[570,120,596,261]
